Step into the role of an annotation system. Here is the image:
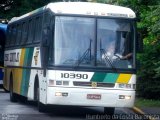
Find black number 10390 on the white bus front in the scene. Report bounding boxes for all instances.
[61,73,88,79]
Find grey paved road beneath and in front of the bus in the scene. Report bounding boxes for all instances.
[0,89,145,120]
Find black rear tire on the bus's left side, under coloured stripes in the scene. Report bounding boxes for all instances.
[9,75,17,102]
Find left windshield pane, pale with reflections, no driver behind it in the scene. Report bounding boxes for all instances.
[54,17,95,66]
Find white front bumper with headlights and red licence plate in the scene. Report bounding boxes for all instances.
[46,87,135,107]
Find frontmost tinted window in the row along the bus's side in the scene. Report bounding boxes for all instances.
[34,17,42,43]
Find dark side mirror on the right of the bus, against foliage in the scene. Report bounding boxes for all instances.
[136,33,143,53]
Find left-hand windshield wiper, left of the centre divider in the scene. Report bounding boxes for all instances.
[75,39,92,68]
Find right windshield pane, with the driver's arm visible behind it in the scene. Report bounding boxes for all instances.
[97,19,133,68]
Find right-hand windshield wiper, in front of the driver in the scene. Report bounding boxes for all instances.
[100,39,117,72]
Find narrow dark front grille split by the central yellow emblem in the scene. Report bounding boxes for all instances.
[73,81,115,88]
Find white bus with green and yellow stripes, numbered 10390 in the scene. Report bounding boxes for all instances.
[4,2,140,114]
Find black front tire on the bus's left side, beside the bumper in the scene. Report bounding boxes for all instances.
[34,81,46,112]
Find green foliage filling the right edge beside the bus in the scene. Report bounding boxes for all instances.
[137,2,160,99]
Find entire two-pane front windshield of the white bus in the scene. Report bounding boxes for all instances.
[50,16,135,69]
